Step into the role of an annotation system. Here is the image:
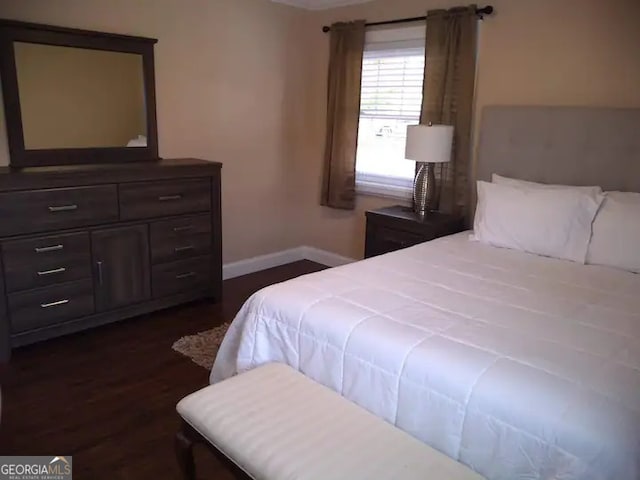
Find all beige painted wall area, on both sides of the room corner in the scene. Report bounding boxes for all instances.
[0,0,640,262]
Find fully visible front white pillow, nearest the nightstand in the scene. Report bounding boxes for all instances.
[474,181,604,263]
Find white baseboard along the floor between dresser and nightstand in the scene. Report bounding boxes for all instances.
[222,246,356,280]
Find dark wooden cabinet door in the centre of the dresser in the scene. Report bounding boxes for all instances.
[91,225,151,312]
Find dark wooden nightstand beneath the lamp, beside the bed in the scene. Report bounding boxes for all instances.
[364,205,465,258]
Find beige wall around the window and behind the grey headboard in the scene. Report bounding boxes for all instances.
[288,0,640,257]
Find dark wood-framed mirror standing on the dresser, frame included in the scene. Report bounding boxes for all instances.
[0,21,158,167]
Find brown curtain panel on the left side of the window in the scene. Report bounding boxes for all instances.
[321,20,365,209]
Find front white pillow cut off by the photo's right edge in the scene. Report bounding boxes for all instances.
[587,192,640,273]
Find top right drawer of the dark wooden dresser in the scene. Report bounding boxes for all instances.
[120,179,211,220]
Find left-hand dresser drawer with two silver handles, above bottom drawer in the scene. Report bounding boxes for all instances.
[2,233,91,292]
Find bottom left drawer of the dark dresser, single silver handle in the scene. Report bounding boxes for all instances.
[8,280,94,333]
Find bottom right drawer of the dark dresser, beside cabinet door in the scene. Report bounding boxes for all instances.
[151,256,211,297]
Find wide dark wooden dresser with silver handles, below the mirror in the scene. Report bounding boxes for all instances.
[0,159,222,361]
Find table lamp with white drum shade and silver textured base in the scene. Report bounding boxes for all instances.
[405,124,453,216]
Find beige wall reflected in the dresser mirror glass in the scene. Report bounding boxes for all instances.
[14,42,147,150]
